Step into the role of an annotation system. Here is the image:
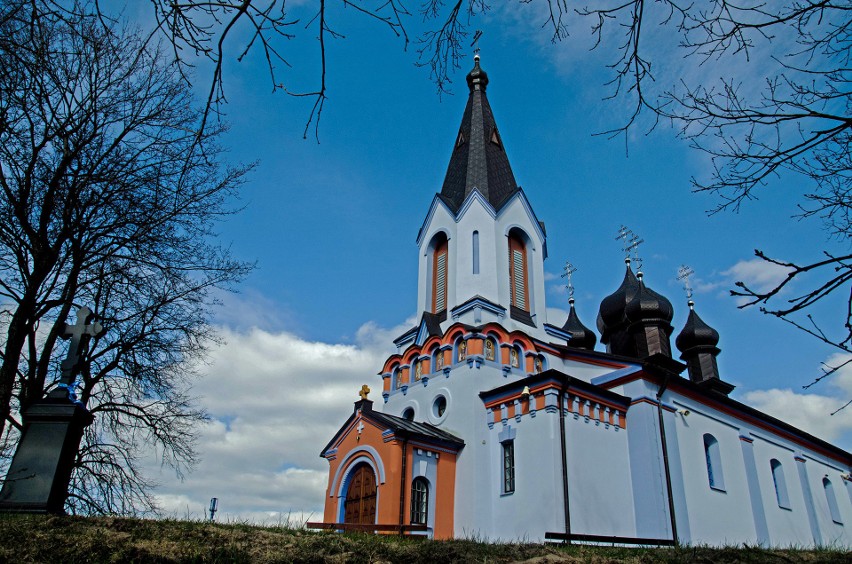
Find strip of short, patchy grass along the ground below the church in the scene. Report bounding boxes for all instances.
[0,515,852,564]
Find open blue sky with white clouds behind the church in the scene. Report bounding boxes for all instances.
[135,4,852,522]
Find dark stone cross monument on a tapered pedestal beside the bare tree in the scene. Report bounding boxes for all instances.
[0,307,103,514]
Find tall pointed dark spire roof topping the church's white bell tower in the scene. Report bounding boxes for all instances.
[441,55,518,213]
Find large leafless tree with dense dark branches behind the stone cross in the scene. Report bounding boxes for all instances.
[0,0,251,513]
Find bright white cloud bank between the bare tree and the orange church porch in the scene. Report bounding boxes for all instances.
[151,322,402,524]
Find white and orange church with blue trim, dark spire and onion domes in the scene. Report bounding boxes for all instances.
[314,56,852,546]
